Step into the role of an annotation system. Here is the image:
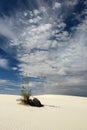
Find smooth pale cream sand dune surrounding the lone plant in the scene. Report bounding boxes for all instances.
[0,95,87,130]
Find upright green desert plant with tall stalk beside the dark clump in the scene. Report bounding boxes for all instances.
[21,76,32,104]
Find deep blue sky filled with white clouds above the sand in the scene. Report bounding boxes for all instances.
[0,0,87,96]
